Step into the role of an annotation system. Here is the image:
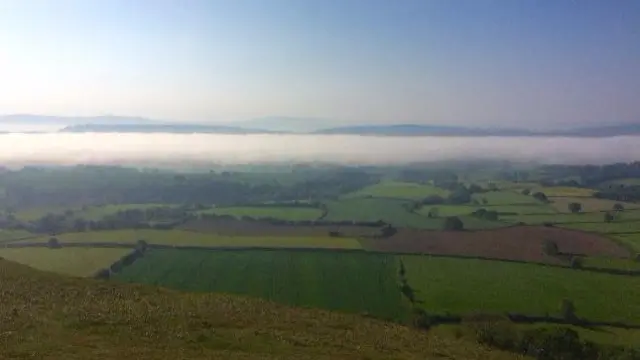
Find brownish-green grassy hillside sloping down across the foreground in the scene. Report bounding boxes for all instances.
[0,260,521,360]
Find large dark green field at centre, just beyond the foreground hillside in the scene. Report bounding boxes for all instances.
[116,250,406,320]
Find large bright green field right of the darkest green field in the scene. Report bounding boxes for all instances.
[401,255,640,324]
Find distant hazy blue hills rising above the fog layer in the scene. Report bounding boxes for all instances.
[0,115,640,137]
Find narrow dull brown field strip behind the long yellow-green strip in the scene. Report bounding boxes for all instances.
[179,219,380,237]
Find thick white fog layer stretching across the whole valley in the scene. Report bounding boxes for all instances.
[0,133,640,166]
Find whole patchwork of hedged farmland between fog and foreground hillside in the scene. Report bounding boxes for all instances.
[0,164,640,360]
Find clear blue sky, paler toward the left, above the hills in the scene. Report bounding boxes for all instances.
[0,0,640,128]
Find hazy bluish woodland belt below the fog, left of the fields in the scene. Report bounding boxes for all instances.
[0,166,379,208]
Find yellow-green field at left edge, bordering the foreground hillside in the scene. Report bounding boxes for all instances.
[0,248,131,276]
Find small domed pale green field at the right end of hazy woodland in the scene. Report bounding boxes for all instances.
[344,181,449,200]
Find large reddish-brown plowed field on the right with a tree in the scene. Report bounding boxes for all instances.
[362,226,629,263]
